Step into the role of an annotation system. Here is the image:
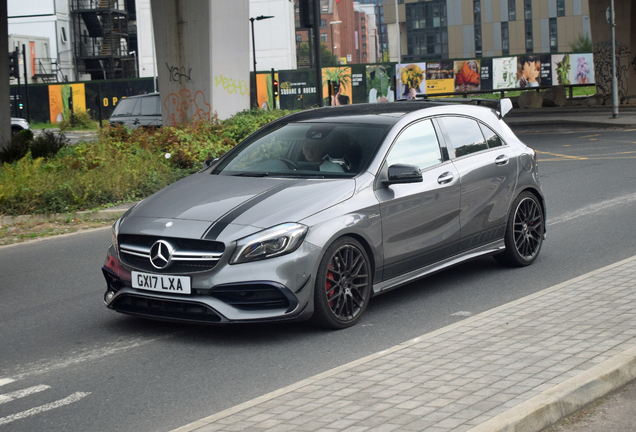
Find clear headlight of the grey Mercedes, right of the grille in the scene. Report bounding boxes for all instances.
[230,223,308,264]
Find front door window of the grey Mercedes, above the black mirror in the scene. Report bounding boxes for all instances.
[386,120,442,170]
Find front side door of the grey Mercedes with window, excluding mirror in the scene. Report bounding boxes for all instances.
[375,119,460,280]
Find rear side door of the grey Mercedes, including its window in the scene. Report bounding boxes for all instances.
[439,116,517,253]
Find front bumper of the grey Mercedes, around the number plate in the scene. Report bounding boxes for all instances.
[102,242,322,324]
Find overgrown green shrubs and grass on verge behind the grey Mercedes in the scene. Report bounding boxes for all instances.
[0,110,289,215]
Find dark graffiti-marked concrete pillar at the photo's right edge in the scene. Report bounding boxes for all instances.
[588,0,636,101]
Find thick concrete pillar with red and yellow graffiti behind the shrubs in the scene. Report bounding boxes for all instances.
[151,0,250,125]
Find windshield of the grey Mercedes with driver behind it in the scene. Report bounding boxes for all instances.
[213,122,388,178]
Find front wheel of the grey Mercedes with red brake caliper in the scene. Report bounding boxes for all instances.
[312,237,372,329]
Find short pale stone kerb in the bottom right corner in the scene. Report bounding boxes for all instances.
[469,347,636,432]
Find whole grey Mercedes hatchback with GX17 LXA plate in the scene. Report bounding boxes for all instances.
[103,100,546,328]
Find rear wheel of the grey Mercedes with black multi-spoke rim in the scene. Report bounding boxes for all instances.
[495,192,545,267]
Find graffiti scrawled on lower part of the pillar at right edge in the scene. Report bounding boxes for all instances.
[594,41,631,97]
